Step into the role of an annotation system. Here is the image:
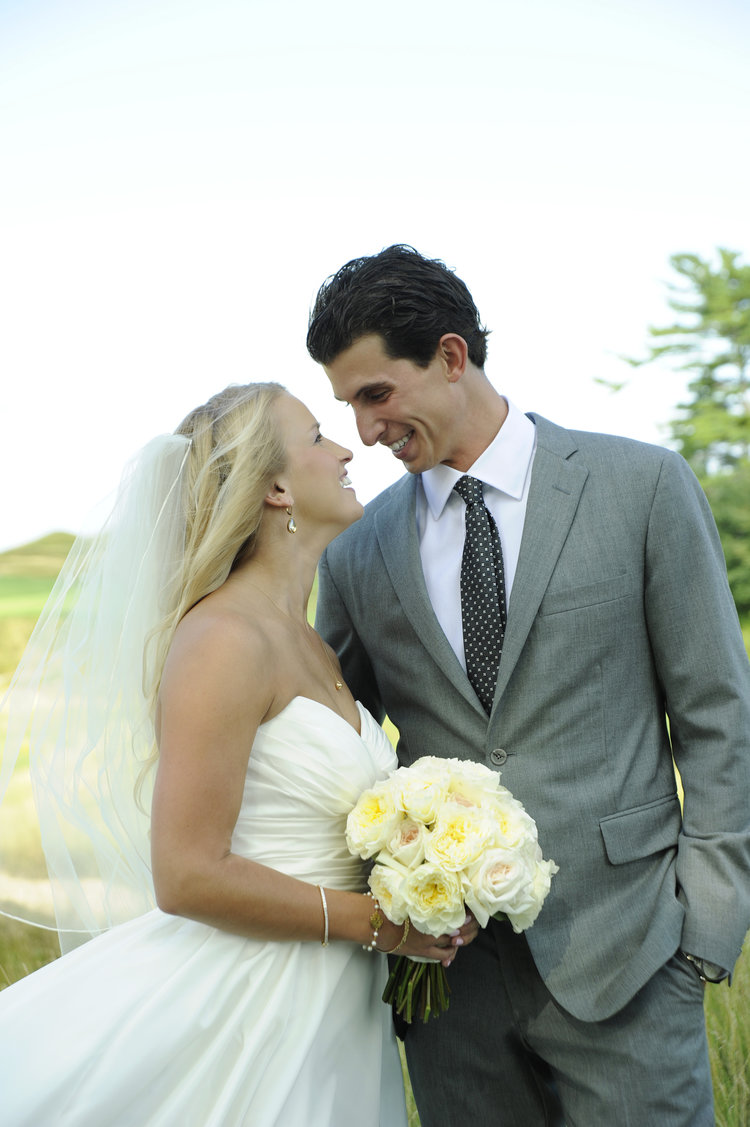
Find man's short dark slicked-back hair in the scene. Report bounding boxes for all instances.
[307,243,488,367]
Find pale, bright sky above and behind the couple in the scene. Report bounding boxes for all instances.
[0,0,750,551]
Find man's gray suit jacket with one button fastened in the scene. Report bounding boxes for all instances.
[318,417,750,1021]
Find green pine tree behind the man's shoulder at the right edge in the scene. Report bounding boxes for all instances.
[628,248,750,615]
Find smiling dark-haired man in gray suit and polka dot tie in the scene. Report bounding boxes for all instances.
[308,246,750,1127]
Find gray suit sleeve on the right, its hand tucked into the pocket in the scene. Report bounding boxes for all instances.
[645,455,750,968]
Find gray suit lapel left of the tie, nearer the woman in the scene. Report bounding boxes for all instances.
[374,474,486,716]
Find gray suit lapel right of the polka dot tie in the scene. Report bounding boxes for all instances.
[493,417,589,711]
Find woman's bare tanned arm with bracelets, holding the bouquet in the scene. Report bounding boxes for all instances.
[151,609,471,961]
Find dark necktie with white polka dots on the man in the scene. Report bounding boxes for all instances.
[453,474,505,715]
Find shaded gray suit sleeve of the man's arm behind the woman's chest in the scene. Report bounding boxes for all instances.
[315,551,386,724]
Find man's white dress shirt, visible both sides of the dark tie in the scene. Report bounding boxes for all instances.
[416,400,537,668]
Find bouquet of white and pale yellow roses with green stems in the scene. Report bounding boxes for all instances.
[346,755,557,1021]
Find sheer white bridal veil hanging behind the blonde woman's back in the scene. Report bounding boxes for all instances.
[0,435,189,950]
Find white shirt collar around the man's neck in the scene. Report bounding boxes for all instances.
[422,399,536,521]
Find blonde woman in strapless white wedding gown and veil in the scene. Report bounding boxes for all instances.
[0,383,476,1127]
